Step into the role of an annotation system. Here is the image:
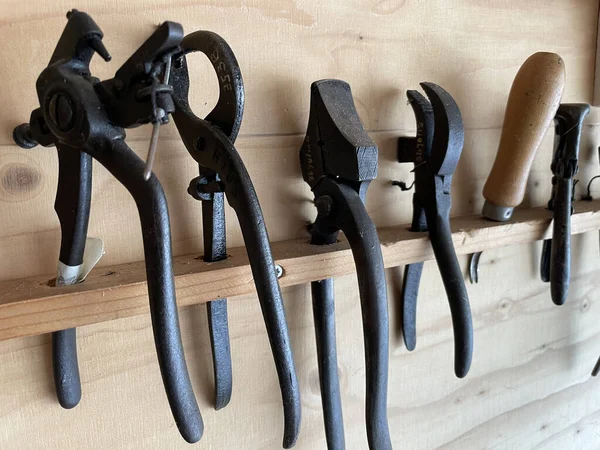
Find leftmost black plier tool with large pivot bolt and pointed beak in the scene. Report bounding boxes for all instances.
[14,10,204,442]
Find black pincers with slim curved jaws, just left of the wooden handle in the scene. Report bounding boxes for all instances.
[395,83,473,378]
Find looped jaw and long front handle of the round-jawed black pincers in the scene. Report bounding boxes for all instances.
[171,31,301,448]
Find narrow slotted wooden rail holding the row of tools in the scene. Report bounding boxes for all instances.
[0,201,600,340]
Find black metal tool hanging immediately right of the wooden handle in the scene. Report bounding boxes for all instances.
[540,103,590,305]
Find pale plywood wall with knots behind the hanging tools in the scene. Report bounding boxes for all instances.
[0,0,600,449]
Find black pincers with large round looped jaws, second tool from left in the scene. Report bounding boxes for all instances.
[170,27,301,448]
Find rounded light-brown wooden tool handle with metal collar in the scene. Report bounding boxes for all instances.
[483,52,565,220]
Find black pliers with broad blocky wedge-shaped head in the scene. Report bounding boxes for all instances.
[300,80,392,450]
